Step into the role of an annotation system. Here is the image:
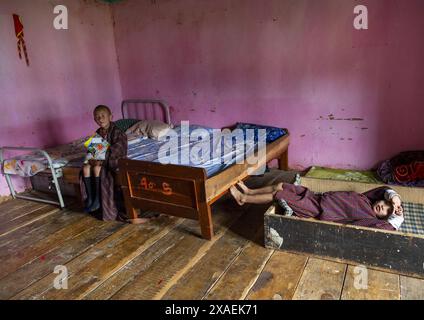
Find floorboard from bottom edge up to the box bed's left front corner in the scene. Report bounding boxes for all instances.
[205,232,274,300]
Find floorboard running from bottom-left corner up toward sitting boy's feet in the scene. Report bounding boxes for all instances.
[0,222,124,299]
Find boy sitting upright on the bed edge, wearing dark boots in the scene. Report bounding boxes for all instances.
[81,105,127,221]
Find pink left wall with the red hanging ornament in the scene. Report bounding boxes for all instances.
[0,0,122,195]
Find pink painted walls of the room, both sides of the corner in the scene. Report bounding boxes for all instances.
[0,0,424,195]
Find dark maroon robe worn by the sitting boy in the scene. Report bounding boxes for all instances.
[80,122,128,221]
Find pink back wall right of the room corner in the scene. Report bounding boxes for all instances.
[113,0,424,168]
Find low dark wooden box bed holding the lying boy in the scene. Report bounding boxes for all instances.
[264,177,424,277]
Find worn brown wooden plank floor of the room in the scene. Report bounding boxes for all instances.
[0,172,424,300]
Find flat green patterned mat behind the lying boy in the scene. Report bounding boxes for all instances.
[306,167,381,183]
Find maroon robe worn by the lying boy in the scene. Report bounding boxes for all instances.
[275,183,395,230]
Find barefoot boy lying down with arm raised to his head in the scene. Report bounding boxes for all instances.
[230,182,404,230]
